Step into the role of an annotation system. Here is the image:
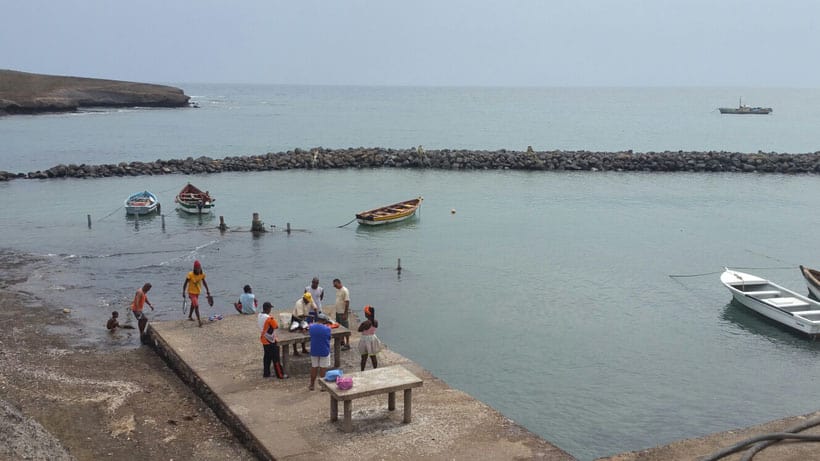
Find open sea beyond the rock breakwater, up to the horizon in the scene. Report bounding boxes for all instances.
[0,85,820,172]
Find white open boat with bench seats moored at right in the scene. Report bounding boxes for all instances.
[720,268,820,339]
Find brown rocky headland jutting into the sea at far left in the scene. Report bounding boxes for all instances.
[0,70,190,115]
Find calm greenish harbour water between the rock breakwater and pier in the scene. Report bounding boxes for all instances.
[0,170,820,459]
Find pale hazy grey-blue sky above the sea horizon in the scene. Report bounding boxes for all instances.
[0,0,820,88]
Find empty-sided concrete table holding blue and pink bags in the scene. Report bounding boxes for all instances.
[319,365,424,432]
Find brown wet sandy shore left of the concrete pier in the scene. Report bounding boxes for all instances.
[0,253,256,461]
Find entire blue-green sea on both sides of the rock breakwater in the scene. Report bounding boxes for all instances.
[0,83,820,460]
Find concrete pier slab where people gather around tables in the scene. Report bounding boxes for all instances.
[148,312,573,461]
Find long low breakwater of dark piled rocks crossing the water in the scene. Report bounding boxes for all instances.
[0,147,820,181]
